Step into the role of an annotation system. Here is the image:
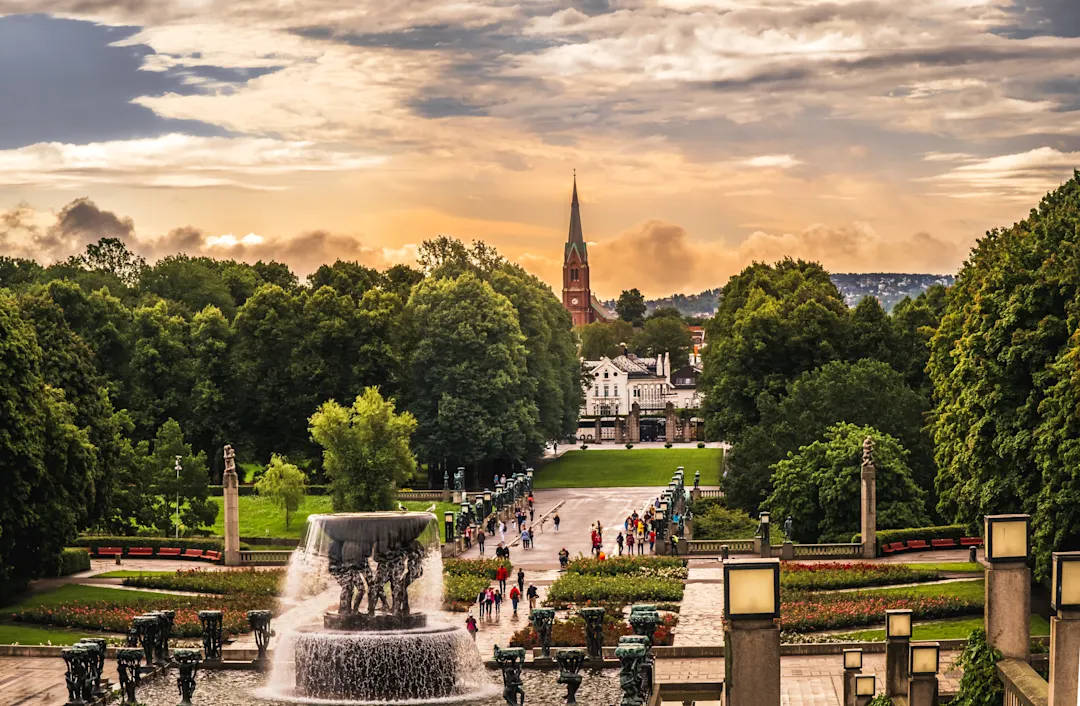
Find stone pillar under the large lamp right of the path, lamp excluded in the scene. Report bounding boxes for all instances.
[724,620,780,706]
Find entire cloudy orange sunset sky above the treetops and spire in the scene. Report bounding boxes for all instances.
[0,0,1080,298]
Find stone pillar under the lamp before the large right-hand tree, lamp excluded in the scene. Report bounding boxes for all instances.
[985,562,1032,662]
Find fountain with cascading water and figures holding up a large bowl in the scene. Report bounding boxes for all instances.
[265,512,494,703]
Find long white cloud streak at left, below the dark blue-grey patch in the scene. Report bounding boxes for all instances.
[0,134,382,190]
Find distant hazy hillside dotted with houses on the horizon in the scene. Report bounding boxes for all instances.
[603,272,954,317]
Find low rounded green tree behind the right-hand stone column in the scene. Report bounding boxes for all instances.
[765,423,929,543]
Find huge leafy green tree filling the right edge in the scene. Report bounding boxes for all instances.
[927,173,1080,578]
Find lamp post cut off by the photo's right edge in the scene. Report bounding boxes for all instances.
[1050,552,1080,704]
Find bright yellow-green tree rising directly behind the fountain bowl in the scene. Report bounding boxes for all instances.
[309,388,417,513]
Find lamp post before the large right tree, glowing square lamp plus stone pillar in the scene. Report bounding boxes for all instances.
[983,515,1031,662]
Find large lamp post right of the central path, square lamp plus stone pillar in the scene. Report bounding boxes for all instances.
[724,559,780,706]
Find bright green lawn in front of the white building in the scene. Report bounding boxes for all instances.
[534,448,724,488]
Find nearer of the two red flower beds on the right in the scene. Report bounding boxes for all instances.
[780,592,983,632]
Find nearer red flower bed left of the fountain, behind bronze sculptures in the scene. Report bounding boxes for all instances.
[11,594,278,637]
